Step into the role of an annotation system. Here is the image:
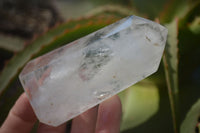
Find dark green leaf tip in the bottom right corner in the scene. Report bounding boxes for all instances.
[180,99,200,133]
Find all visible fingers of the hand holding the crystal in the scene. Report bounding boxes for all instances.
[0,93,122,133]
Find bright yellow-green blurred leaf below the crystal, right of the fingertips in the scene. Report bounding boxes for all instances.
[119,81,159,131]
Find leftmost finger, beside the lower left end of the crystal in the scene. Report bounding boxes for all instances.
[0,93,37,133]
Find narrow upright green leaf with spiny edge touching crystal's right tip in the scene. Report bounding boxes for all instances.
[163,19,179,133]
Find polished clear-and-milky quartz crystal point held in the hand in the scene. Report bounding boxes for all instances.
[19,16,167,126]
